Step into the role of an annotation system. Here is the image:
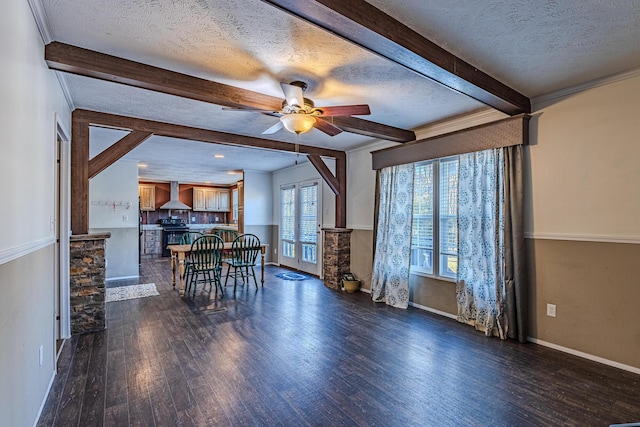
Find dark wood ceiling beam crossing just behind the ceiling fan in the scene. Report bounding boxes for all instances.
[44,42,416,142]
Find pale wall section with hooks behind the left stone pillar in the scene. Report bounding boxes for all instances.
[89,160,140,280]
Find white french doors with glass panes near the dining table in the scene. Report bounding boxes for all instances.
[280,181,322,276]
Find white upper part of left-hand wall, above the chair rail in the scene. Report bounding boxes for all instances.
[0,2,71,262]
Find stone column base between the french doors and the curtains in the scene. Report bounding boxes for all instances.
[322,228,352,290]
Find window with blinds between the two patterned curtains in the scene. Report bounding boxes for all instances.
[411,157,458,279]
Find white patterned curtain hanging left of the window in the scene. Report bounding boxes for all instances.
[371,164,414,308]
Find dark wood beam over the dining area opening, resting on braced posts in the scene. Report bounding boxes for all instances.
[74,110,346,158]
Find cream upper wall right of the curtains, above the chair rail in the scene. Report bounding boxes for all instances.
[526,73,640,242]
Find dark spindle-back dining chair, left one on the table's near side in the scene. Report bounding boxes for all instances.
[185,234,224,297]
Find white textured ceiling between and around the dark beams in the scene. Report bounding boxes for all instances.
[33,0,640,184]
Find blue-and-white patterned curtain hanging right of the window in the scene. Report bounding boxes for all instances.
[456,149,506,339]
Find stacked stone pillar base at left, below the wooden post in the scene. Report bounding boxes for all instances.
[69,233,111,335]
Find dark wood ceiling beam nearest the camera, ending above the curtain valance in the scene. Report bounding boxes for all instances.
[263,0,531,115]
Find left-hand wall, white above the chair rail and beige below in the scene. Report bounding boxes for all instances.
[0,1,71,426]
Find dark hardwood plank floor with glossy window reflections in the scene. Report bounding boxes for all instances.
[38,258,640,427]
